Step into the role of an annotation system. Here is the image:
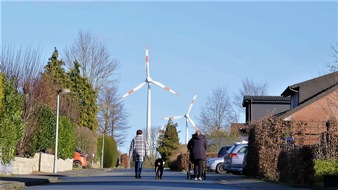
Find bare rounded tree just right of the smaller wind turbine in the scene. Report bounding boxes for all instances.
[199,87,238,134]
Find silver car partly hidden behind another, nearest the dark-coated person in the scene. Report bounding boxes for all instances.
[206,145,231,173]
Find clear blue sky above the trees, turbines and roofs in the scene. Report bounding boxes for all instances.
[0,1,338,152]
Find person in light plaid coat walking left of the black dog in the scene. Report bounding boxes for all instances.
[129,129,148,178]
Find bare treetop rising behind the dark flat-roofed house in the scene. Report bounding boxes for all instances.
[233,78,268,113]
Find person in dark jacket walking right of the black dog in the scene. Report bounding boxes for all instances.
[187,130,207,180]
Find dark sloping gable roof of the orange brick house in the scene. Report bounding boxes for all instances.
[281,71,338,105]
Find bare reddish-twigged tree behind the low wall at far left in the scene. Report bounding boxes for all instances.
[0,45,46,155]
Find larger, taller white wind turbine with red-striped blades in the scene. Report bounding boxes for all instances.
[121,45,178,145]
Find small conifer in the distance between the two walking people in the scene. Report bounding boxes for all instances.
[157,120,180,160]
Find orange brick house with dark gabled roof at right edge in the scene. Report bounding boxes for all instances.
[279,72,338,144]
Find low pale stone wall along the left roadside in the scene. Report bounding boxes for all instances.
[0,153,73,175]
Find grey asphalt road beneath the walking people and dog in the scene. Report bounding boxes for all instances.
[24,169,306,190]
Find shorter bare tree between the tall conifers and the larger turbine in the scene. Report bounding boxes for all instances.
[98,86,129,145]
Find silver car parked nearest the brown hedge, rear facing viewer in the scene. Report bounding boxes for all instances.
[223,142,248,173]
